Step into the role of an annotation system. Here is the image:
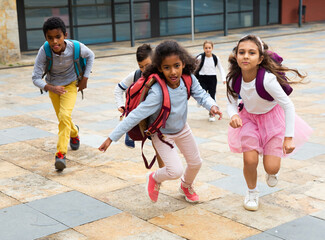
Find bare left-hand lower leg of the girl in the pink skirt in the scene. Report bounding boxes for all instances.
[243,150,258,189]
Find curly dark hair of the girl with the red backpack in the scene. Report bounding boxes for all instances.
[143,40,196,79]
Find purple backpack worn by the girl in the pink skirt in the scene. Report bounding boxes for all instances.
[232,51,293,101]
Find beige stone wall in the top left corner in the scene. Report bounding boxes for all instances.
[0,0,20,63]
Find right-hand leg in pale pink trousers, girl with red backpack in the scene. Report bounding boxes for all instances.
[175,124,202,187]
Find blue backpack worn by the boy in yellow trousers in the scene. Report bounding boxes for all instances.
[41,39,86,98]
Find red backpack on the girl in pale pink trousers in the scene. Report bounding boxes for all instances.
[124,74,192,169]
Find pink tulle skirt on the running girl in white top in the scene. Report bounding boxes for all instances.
[228,105,313,157]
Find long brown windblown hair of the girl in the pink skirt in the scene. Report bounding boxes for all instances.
[227,35,306,98]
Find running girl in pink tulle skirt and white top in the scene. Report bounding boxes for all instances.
[227,35,312,211]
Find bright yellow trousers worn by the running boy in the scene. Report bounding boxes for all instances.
[49,81,78,154]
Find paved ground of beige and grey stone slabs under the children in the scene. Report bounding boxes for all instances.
[0,23,325,240]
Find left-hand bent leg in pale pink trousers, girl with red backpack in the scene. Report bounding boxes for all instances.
[151,134,183,183]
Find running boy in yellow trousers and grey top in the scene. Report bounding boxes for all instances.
[32,17,95,171]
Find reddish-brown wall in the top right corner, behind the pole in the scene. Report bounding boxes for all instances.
[281,0,325,24]
